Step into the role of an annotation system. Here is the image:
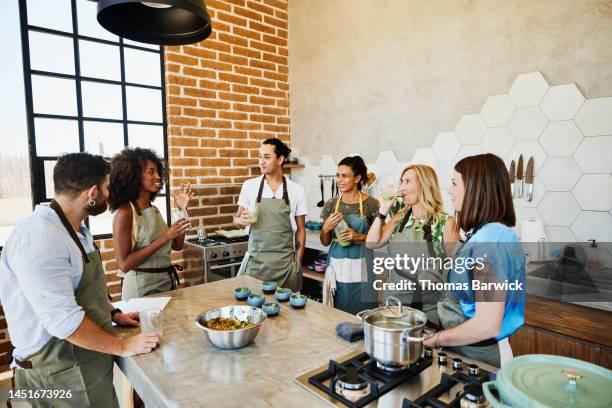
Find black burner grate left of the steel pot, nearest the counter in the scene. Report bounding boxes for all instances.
[308,353,432,408]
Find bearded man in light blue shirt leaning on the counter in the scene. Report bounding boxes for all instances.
[0,153,159,408]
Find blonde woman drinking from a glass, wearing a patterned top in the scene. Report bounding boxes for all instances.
[366,164,459,326]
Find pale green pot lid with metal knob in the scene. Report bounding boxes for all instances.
[497,354,612,408]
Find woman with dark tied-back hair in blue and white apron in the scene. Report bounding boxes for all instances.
[319,156,378,314]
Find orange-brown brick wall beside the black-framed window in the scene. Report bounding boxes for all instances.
[0,0,290,370]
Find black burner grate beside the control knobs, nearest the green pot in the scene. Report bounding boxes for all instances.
[402,369,495,408]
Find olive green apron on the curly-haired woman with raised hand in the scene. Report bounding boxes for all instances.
[121,203,176,300]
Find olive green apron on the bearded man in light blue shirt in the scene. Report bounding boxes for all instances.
[15,201,119,408]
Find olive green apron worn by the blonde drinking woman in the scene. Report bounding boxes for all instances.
[385,213,444,327]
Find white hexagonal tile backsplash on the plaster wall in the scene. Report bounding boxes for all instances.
[294,72,612,242]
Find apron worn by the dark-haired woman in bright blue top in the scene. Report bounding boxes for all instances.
[438,234,501,367]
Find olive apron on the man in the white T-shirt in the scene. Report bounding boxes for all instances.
[237,176,302,292]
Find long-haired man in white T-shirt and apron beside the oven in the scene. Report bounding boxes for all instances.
[234,139,308,292]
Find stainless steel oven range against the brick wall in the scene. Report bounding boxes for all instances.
[185,235,249,283]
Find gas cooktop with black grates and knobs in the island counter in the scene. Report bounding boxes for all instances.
[295,349,497,408]
